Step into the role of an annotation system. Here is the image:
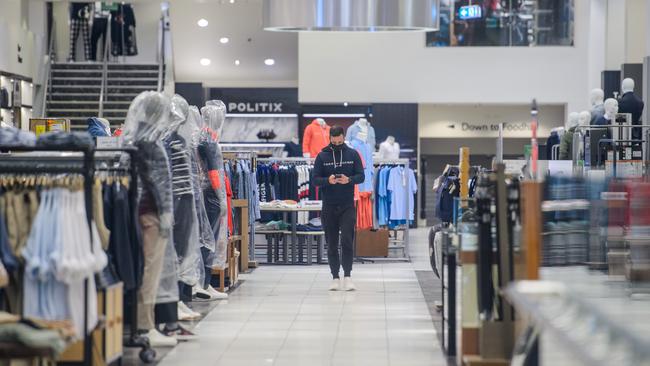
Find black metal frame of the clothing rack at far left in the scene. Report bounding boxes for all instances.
[0,146,95,365]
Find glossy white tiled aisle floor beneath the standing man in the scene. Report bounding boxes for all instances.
[161,231,446,366]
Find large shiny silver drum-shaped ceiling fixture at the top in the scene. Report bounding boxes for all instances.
[264,0,440,32]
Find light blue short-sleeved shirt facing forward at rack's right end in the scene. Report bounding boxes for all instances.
[387,166,418,220]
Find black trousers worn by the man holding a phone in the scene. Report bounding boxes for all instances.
[321,204,357,278]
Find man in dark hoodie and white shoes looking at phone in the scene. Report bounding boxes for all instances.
[314,126,365,291]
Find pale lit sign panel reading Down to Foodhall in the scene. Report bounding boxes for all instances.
[418,105,564,138]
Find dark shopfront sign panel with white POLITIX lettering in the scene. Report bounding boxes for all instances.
[208,88,300,114]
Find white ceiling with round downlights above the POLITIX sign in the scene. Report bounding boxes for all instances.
[169,0,298,87]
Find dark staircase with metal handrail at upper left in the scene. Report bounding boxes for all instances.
[47,63,158,130]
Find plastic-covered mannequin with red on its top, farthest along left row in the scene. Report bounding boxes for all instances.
[199,100,228,268]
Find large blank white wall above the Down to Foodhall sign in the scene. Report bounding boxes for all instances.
[299,0,604,117]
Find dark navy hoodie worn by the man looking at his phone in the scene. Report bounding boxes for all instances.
[313,144,365,205]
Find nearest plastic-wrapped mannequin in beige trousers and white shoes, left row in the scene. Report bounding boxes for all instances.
[124,92,178,346]
